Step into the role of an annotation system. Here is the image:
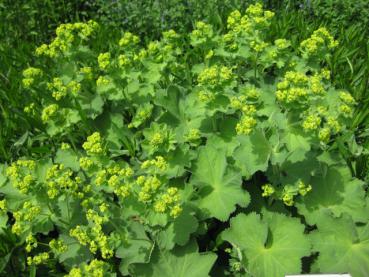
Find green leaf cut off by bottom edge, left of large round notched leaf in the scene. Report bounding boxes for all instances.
[132,239,217,277]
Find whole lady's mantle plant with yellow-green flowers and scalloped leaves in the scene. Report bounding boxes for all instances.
[0,4,369,277]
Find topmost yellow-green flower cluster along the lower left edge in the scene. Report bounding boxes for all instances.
[6,160,36,194]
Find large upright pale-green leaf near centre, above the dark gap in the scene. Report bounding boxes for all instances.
[191,145,250,221]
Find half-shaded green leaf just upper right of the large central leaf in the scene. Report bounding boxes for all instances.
[234,130,271,177]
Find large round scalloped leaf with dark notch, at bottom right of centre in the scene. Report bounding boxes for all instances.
[222,213,310,277]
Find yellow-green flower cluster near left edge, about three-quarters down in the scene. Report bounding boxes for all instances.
[12,201,41,235]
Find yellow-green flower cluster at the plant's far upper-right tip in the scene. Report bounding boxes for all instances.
[300,27,338,56]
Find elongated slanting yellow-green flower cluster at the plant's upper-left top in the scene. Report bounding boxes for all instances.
[35,20,99,58]
